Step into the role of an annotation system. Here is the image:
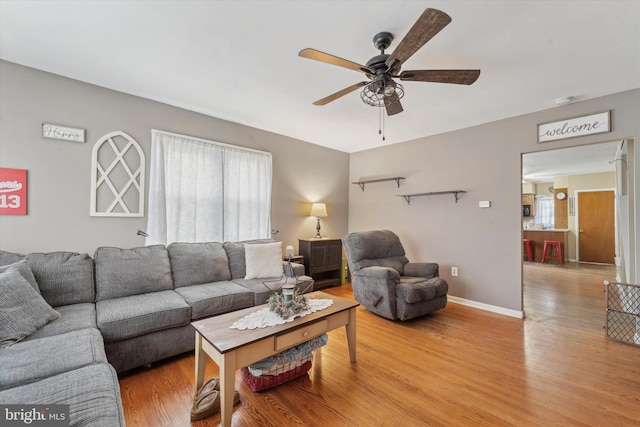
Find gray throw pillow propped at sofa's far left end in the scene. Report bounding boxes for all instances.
[0,267,60,349]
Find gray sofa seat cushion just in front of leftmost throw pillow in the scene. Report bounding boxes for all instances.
[0,328,107,390]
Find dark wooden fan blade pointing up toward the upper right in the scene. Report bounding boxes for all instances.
[385,9,451,70]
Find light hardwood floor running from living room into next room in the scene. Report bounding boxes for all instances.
[120,265,640,426]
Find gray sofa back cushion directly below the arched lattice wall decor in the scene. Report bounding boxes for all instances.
[94,245,173,301]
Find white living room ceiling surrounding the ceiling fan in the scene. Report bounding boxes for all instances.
[0,0,640,153]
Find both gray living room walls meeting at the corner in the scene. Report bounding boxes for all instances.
[0,61,640,311]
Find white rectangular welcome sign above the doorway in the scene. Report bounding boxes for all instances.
[538,110,611,143]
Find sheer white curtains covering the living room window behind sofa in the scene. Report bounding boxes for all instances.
[145,130,271,245]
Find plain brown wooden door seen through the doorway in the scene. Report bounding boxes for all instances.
[577,190,615,264]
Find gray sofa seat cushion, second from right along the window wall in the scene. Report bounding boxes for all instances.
[176,281,253,320]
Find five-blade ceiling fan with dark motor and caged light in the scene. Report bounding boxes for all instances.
[298,9,480,116]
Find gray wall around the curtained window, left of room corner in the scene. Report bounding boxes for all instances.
[0,61,349,255]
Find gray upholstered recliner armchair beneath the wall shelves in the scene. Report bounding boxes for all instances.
[342,230,449,320]
